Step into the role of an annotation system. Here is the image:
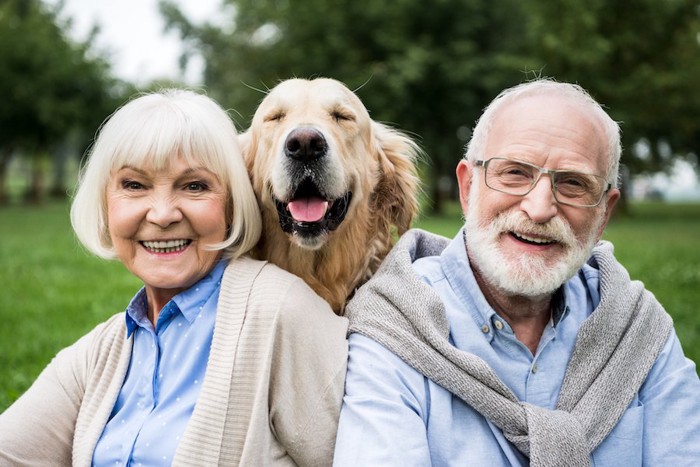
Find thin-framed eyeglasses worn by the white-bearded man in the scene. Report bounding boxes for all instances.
[474,157,612,208]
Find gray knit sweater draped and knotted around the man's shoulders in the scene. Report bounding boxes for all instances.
[346,230,673,467]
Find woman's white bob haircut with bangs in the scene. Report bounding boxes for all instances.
[70,89,262,259]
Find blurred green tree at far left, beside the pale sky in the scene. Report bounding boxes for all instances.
[0,0,119,202]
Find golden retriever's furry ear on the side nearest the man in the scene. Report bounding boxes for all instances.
[372,122,423,235]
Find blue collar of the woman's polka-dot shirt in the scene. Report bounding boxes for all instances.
[126,260,228,339]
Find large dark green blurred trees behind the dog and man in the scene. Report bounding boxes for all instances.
[160,0,700,209]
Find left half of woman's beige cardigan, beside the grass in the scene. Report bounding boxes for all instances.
[0,313,130,466]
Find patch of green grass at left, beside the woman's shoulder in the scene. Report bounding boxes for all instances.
[0,203,140,410]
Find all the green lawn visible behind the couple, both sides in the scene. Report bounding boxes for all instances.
[0,203,700,411]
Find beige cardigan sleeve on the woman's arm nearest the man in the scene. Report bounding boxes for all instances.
[270,279,348,466]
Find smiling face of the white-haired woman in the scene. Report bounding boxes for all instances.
[106,157,228,313]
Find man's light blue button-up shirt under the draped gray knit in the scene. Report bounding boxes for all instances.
[334,232,700,467]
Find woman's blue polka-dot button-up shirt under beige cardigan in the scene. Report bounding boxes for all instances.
[93,261,227,466]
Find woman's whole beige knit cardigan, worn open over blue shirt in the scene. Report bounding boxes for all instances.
[0,258,347,466]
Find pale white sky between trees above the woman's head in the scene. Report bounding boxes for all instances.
[45,0,221,84]
